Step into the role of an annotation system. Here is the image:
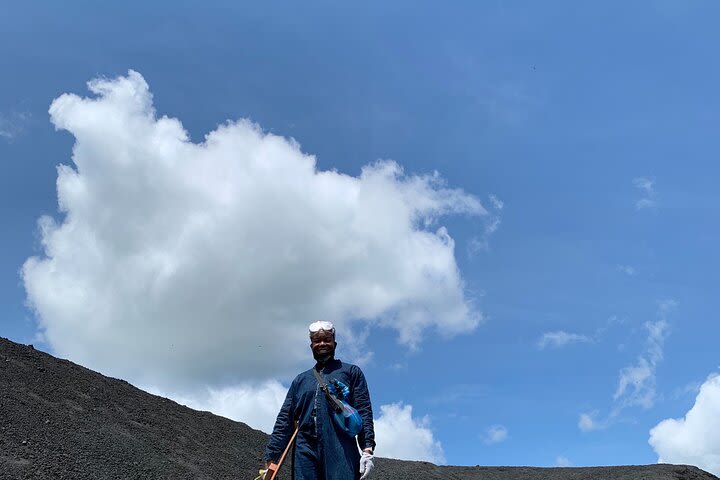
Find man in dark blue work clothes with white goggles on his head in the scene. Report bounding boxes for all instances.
[265,321,375,480]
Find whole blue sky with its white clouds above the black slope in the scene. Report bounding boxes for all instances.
[0,0,720,475]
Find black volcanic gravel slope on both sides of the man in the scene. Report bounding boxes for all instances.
[0,338,717,480]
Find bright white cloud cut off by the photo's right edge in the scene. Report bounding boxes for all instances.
[648,375,720,475]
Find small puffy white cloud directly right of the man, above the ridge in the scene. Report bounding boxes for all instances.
[375,403,445,465]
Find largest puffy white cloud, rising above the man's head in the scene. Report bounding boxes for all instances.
[22,71,487,394]
